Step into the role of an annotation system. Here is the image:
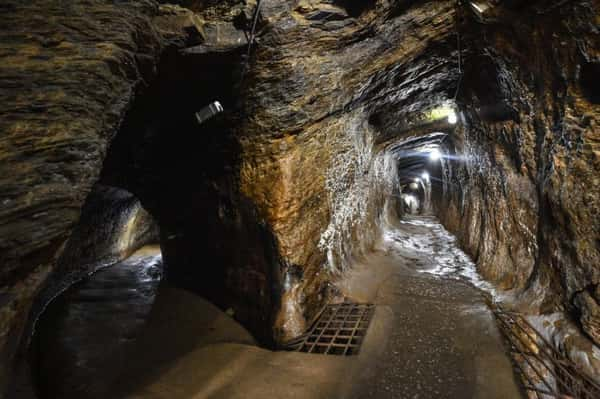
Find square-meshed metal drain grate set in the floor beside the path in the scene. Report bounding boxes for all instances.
[296,303,375,356]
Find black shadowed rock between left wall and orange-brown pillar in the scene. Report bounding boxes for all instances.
[101,44,279,345]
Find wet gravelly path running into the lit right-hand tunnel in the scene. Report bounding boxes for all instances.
[345,217,523,399]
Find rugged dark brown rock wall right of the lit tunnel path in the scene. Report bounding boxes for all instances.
[438,1,600,356]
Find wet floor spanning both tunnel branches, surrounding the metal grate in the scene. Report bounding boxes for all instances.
[19,217,522,399]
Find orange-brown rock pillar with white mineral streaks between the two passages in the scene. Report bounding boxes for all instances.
[238,1,454,340]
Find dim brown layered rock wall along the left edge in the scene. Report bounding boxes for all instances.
[0,0,209,392]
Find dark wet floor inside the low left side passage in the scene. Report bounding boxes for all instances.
[32,247,162,399]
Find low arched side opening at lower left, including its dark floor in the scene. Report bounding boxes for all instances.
[29,185,163,399]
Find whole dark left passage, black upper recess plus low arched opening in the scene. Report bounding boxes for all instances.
[13,41,280,399]
